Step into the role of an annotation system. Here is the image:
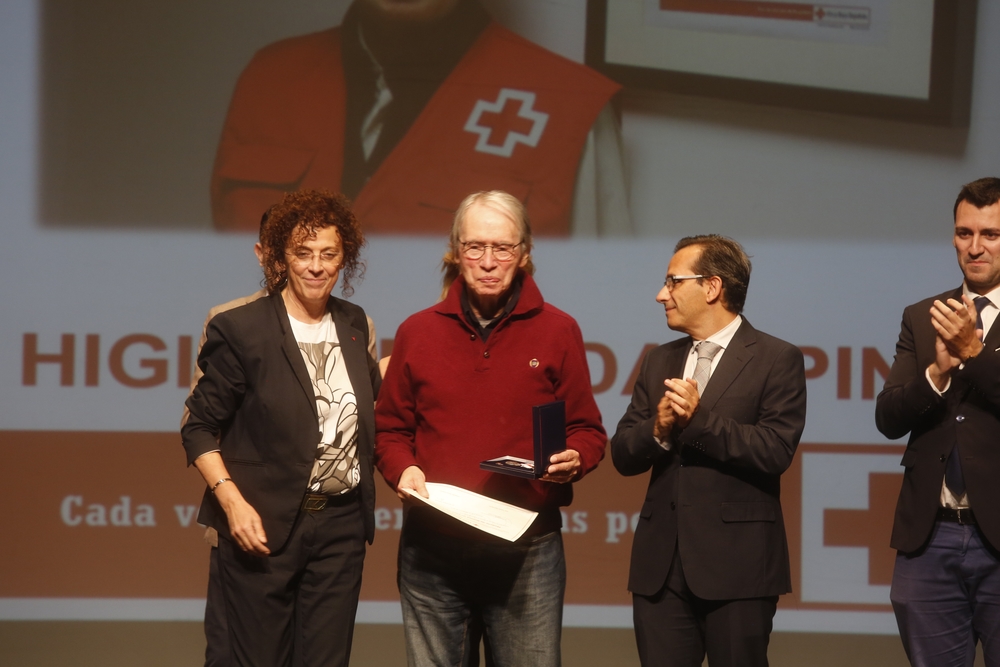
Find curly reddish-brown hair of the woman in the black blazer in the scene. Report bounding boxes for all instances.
[260,190,365,296]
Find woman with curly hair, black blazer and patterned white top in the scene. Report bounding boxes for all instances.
[181,190,381,667]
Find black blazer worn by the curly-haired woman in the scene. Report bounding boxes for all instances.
[181,294,381,552]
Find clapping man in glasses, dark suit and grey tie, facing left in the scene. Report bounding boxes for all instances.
[611,236,806,667]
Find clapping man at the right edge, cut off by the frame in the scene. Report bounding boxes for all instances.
[875,178,1000,667]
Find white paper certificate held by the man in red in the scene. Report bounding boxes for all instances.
[403,482,538,542]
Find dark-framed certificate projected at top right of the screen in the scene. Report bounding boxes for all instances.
[586,0,976,127]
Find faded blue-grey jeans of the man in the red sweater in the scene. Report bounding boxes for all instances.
[399,525,566,667]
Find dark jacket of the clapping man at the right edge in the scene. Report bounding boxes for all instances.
[875,289,1000,553]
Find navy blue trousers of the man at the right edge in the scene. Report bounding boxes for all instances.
[889,521,1000,667]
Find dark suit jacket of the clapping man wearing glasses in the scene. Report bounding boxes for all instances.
[611,319,806,600]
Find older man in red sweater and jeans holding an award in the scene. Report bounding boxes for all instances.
[375,191,607,667]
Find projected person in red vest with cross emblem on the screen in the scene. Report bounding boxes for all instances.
[211,0,631,236]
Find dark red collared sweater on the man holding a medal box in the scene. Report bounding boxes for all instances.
[375,275,607,510]
